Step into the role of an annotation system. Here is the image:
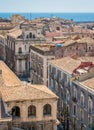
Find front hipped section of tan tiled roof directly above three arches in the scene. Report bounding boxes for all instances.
[0,85,57,102]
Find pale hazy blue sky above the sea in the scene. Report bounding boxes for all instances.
[0,0,94,12]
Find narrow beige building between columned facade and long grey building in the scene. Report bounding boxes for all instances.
[30,44,55,86]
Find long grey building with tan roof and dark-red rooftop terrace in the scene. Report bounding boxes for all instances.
[49,57,94,130]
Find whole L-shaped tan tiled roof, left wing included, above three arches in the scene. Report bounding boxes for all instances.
[0,61,57,102]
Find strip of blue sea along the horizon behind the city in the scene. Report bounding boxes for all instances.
[0,12,94,22]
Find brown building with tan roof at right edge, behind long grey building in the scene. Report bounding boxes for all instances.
[55,37,94,58]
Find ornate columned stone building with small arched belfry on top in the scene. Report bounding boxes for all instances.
[6,28,45,77]
